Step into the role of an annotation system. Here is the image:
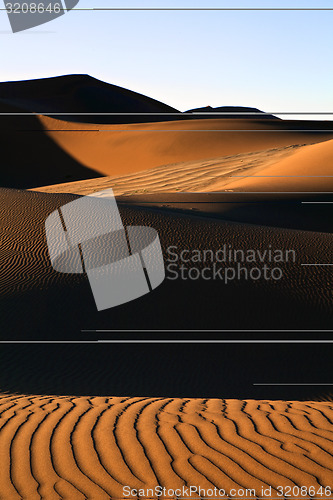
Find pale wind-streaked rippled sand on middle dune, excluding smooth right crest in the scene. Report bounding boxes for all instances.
[34,144,304,196]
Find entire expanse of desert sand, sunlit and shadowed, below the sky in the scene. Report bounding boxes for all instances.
[0,75,333,500]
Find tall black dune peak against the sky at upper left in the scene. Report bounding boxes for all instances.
[0,75,179,123]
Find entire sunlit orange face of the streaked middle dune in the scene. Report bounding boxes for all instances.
[36,141,333,195]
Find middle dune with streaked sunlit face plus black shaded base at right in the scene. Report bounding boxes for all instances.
[36,141,333,232]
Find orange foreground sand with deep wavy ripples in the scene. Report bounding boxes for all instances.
[0,394,333,500]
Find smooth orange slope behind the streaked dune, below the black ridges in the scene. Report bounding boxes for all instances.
[35,116,333,180]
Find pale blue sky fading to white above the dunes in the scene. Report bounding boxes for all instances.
[0,0,333,119]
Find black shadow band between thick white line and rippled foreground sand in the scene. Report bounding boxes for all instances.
[0,342,332,400]
